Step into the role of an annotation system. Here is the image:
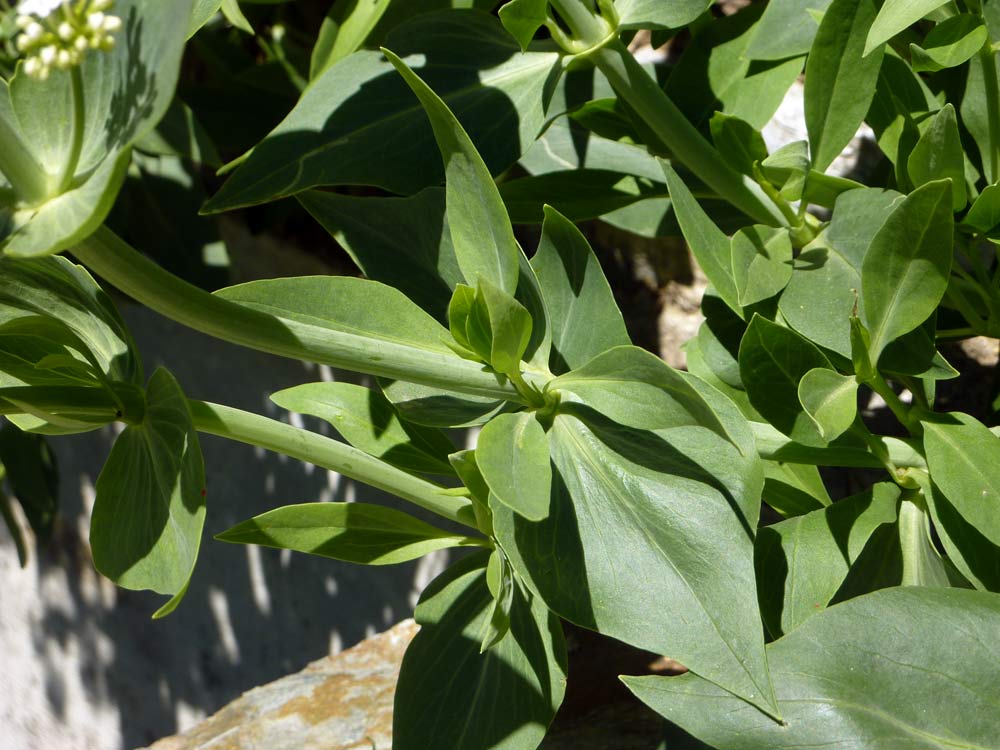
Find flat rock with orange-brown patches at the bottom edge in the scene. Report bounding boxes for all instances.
[147,620,417,750]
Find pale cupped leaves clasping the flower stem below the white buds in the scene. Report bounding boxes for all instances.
[0,0,192,257]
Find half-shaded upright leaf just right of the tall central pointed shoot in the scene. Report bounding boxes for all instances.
[531,206,630,373]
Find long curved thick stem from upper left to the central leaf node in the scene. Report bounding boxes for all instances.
[73,227,521,401]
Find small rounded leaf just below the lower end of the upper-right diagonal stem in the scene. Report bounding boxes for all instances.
[731,224,792,307]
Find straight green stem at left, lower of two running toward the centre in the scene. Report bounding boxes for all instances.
[188,400,476,528]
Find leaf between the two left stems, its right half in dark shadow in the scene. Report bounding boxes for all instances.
[271,383,455,474]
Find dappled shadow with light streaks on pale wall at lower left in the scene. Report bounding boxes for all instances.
[0,309,460,750]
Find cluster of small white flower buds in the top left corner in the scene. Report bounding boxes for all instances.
[17,0,122,81]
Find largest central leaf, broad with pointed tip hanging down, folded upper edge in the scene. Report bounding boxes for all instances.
[493,400,773,724]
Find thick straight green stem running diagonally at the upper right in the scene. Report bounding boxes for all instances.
[584,38,787,226]
